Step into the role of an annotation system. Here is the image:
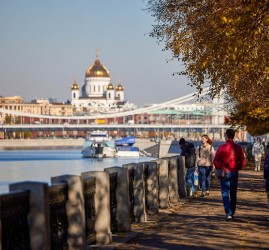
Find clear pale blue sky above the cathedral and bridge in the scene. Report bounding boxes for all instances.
[0,0,194,106]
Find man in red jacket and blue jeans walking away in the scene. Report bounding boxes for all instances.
[213,129,246,221]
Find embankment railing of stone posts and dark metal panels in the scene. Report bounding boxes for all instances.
[0,156,186,250]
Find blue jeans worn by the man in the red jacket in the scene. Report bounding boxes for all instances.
[220,172,238,216]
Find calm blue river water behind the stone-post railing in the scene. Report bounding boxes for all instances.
[0,148,153,193]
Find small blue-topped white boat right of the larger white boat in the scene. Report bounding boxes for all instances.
[115,136,140,158]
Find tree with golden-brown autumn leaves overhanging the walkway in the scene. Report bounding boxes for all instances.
[147,0,269,133]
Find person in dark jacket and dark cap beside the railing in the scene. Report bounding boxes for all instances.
[178,138,197,197]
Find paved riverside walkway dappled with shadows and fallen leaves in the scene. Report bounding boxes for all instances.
[97,170,269,250]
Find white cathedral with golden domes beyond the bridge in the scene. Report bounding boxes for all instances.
[71,55,136,114]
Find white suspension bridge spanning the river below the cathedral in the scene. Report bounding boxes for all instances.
[0,88,233,142]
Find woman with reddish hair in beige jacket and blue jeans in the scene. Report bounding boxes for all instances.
[195,135,215,197]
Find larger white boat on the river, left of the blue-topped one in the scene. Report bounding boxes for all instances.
[81,131,116,158]
